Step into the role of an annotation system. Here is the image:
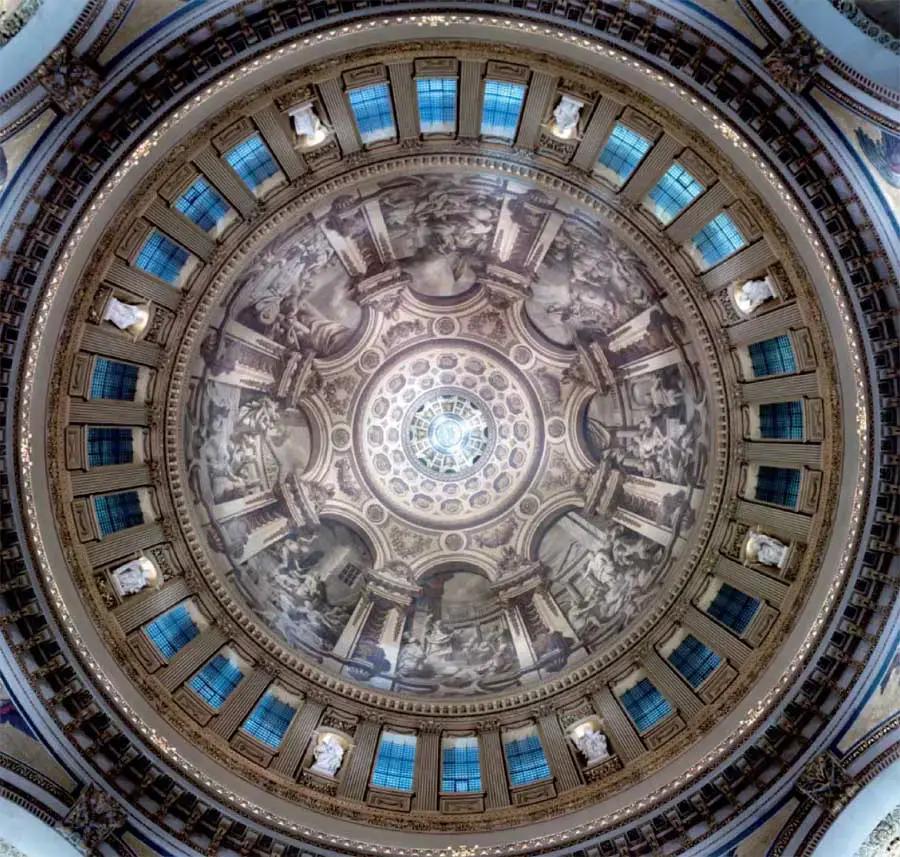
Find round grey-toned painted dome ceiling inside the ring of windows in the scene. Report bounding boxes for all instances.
[185,172,709,696]
